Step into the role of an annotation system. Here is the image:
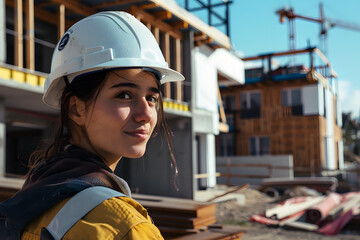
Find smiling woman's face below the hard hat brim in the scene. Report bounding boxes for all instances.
[74,69,160,163]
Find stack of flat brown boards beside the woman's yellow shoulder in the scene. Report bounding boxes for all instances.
[132,194,242,240]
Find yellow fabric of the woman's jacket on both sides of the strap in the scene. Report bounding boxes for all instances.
[21,197,163,240]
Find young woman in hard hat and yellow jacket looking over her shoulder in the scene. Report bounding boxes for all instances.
[0,12,184,240]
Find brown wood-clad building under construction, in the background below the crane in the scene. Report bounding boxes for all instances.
[218,48,344,177]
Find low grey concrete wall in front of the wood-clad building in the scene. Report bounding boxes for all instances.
[216,155,294,185]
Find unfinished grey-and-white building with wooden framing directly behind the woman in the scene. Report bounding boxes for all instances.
[0,0,244,199]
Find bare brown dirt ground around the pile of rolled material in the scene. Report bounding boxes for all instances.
[216,188,360,240]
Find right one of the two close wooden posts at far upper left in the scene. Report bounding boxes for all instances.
[26,0,35,70]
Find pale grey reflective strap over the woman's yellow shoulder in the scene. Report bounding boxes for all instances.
[46,186,126,240]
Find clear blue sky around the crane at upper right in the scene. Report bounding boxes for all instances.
[176,0,360,119]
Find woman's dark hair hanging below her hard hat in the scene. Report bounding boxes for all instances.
[30,71,178,189]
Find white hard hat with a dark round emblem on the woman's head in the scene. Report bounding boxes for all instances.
[43,11,184,108]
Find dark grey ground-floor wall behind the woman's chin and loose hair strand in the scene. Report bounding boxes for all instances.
[116,117,193,199]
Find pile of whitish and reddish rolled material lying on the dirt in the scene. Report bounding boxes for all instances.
[250,192,360,235]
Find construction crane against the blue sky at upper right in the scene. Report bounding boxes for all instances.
[276,3,360,55]
